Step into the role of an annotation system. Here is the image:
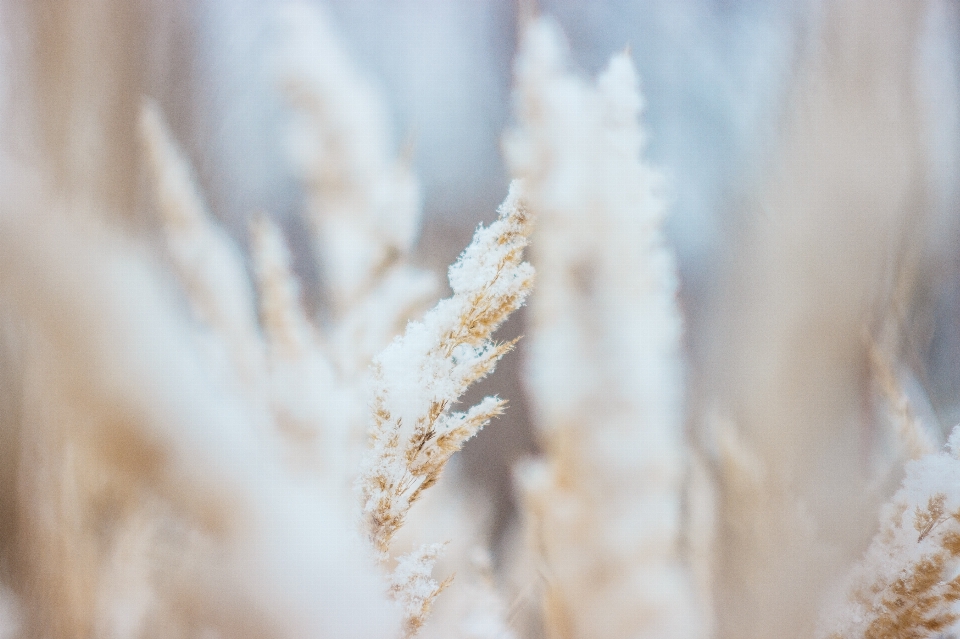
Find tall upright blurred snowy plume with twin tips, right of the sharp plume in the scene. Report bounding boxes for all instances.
[504,20,707,638]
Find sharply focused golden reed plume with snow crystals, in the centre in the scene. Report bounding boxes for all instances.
[358,183,533,634]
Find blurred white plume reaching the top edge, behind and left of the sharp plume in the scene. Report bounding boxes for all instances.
[278,2,438,381]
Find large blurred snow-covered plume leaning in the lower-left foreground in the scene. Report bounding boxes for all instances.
[0,201,399,639]
